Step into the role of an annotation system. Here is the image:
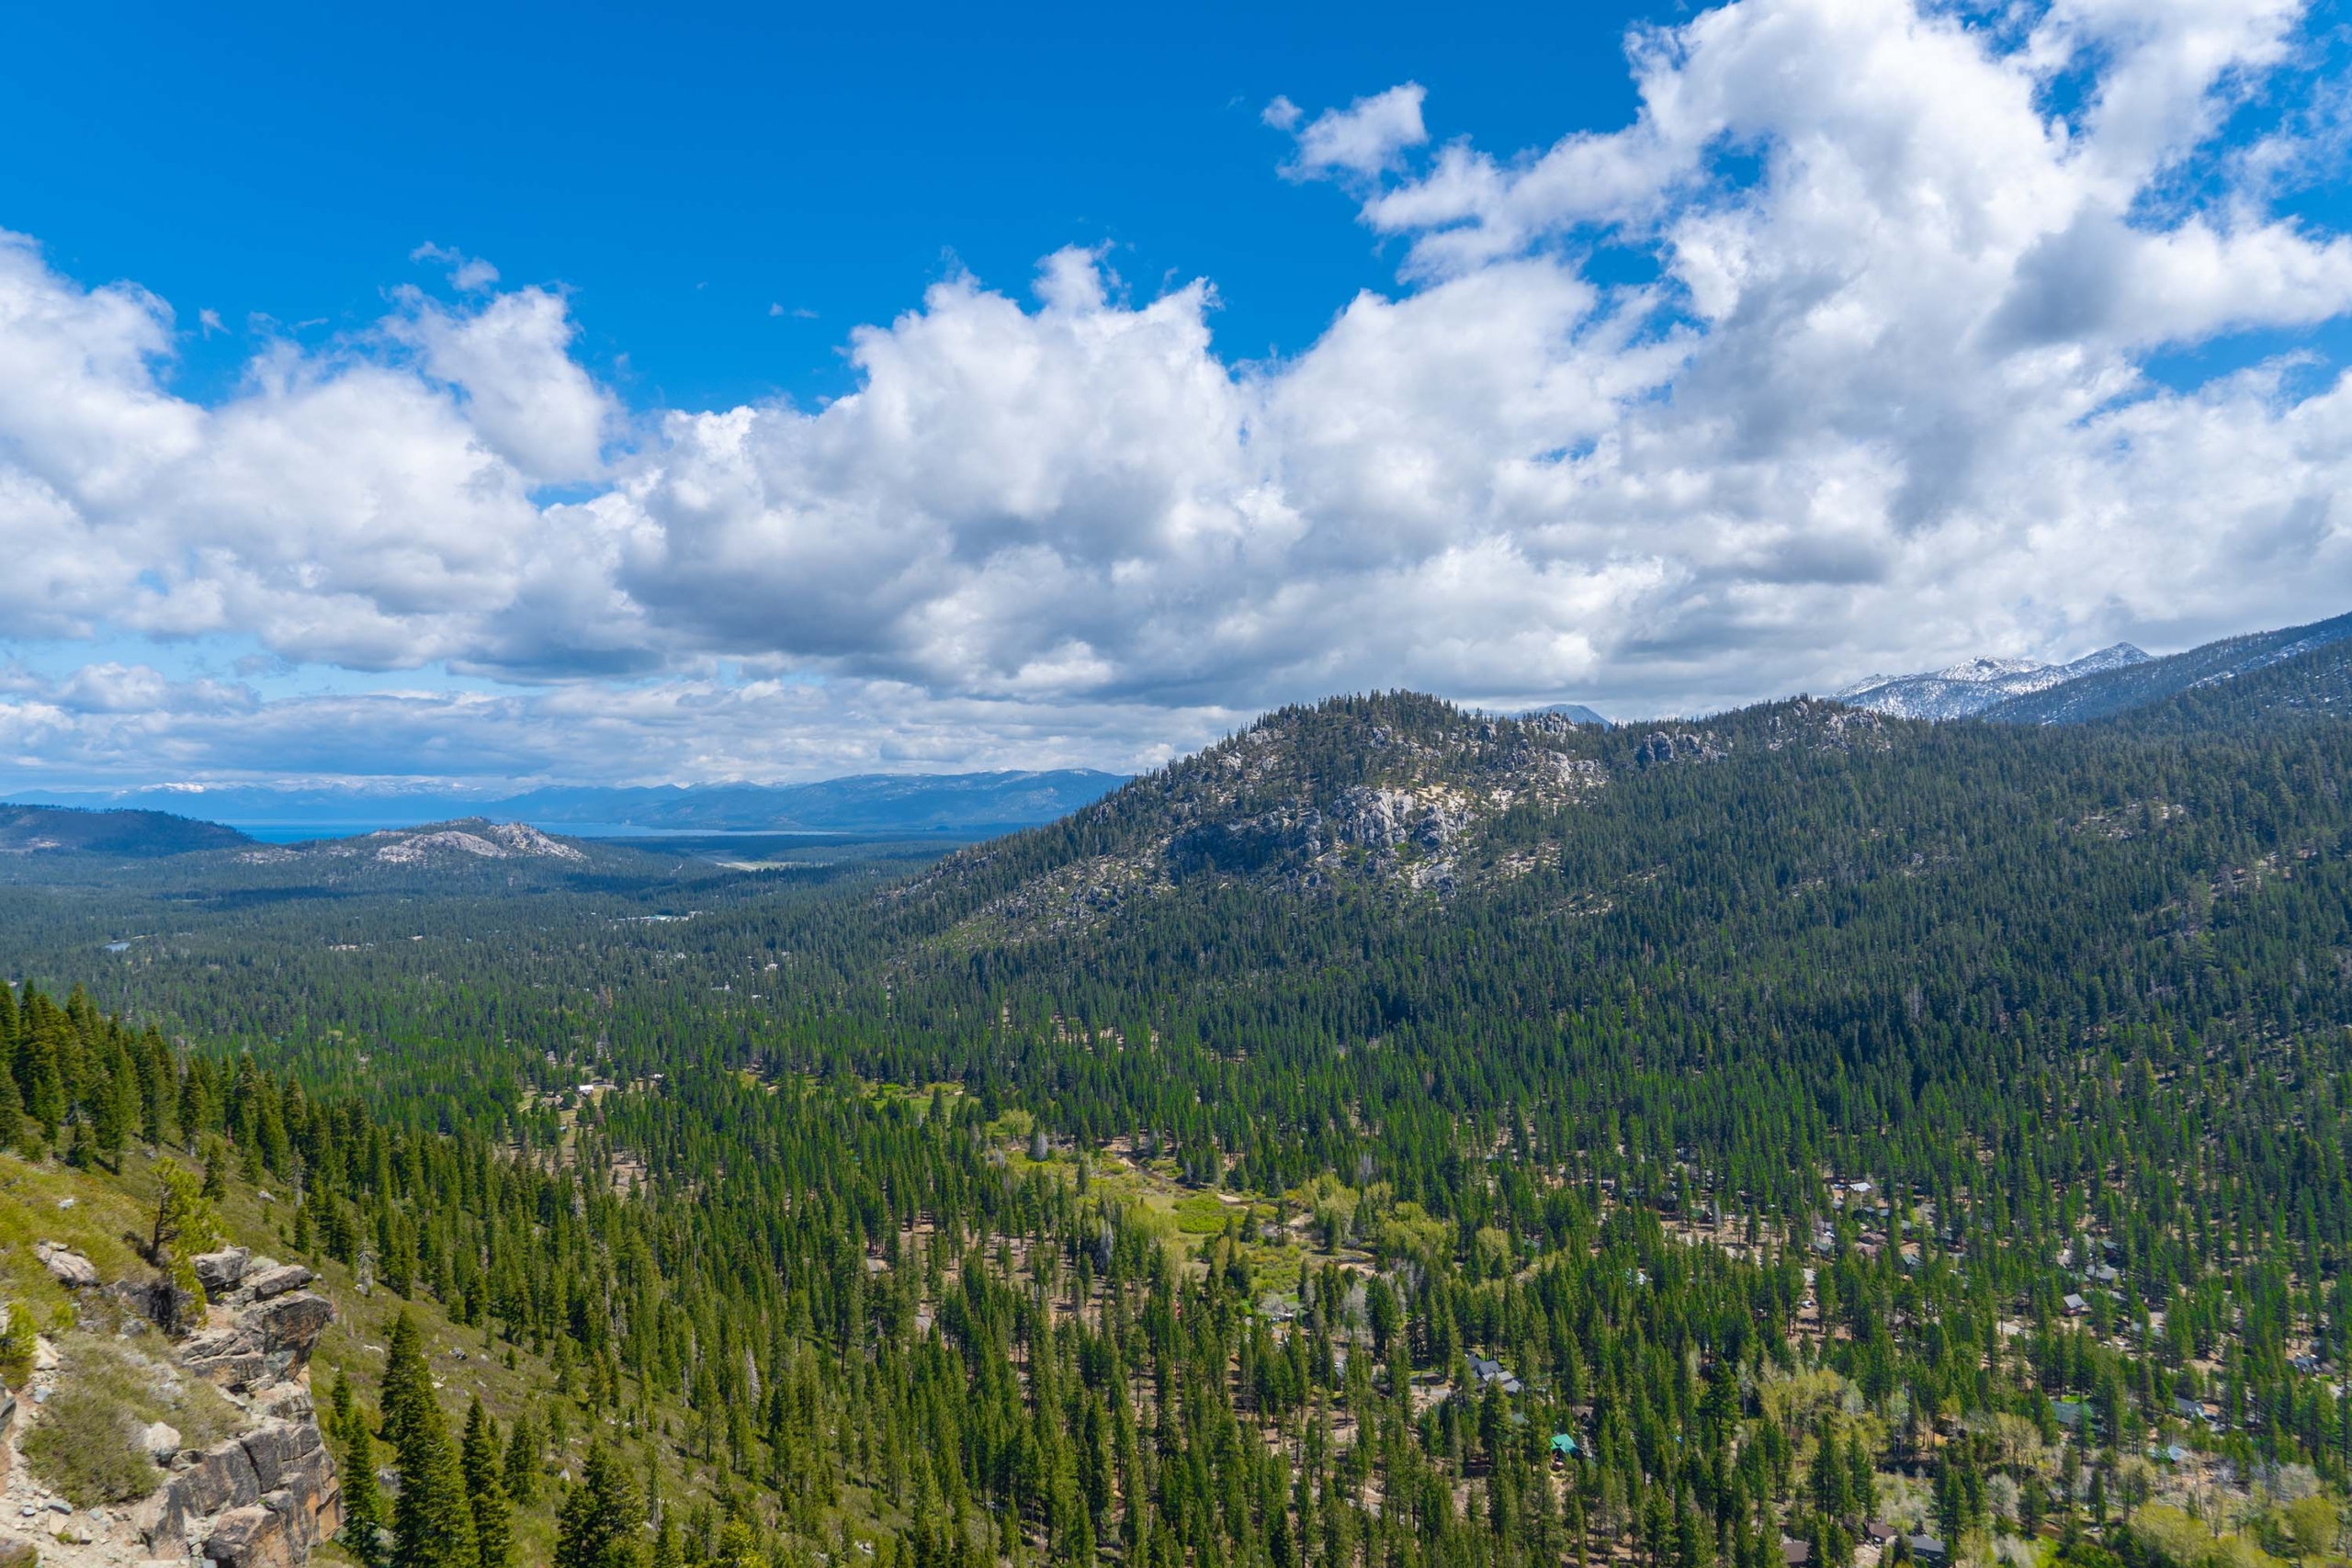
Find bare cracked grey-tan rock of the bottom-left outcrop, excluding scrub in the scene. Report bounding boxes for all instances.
[0,1244,344,1568]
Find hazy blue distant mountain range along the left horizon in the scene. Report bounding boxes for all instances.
[6,769,1126,837]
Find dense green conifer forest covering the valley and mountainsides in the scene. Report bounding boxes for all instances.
[0,644,2352,1568]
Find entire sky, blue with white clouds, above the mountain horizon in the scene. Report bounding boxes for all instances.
[0,0,2352,787]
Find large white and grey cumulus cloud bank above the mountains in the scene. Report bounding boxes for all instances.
[0,0,2352,778]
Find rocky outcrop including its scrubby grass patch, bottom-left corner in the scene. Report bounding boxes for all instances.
[0,1244,341,1568]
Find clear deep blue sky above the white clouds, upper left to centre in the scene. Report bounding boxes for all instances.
[0,5,1672,407]
